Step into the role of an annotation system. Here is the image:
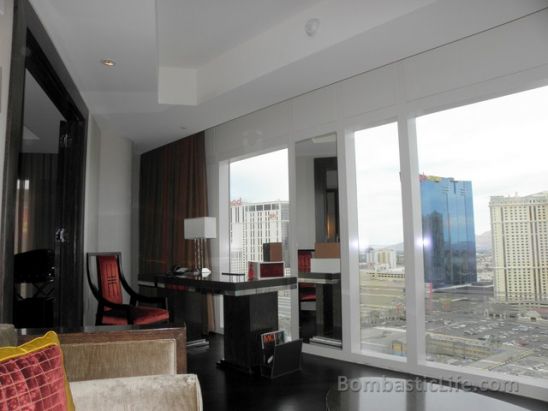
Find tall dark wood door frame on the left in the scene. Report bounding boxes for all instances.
[0,0,89,326]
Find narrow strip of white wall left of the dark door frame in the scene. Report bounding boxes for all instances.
[0,0,13,220]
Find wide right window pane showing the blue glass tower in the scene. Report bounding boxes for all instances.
[417,87,548,378]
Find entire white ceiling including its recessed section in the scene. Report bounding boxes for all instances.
[31,0,546,151]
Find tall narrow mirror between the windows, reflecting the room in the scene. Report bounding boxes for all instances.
[295,133,342,348]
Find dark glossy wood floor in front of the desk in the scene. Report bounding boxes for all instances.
[188,335,548,411]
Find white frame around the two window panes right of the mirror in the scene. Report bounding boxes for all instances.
[340,79,548,398]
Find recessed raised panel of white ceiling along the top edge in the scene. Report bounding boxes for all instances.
[156,0,321,68]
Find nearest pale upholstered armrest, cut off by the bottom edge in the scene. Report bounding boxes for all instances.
[70,374,203,411]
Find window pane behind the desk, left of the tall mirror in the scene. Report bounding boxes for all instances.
[230,149,290,333]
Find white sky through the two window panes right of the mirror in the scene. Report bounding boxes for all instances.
[356,87,548,247]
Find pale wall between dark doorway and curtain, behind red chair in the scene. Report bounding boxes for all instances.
[84,116,137,325]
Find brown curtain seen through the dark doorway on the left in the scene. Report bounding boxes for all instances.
[15,153,57,253]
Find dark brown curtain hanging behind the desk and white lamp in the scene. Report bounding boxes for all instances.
[139,132,215,331]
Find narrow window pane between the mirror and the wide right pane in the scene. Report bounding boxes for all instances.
[355,123,406,356]
